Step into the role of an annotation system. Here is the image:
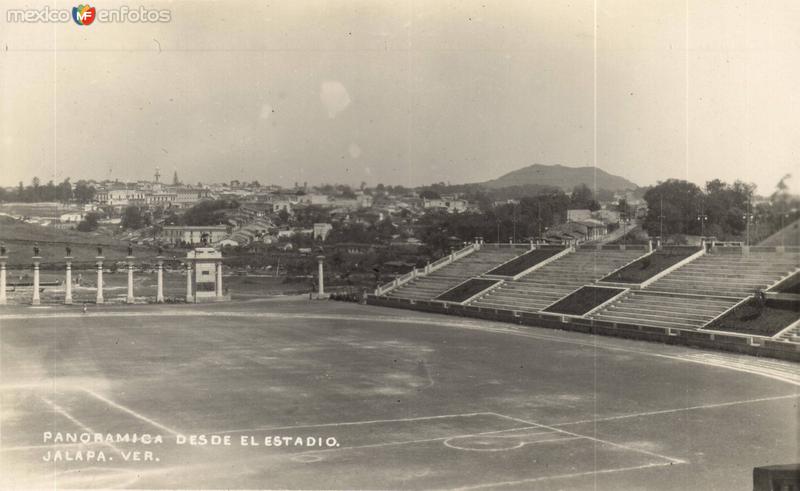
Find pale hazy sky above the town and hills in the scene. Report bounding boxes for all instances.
[0,0,800,194]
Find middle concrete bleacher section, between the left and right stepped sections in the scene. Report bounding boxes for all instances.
[470,248,646,312]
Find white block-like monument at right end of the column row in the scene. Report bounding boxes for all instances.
[186,247,231,303]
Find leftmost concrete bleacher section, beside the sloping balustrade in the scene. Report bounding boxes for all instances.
[386,245,528,300]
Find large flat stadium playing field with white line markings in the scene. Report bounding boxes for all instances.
[0,299,800,490]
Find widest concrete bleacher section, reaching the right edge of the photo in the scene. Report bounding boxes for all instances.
[589,248,800,329]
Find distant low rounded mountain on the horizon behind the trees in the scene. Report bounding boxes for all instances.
[483,164,639,191]
